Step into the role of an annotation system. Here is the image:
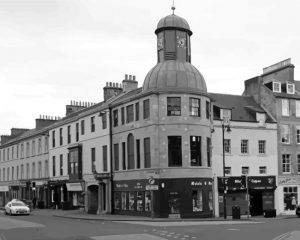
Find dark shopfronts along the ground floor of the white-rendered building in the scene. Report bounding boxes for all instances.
[218,176,276,216]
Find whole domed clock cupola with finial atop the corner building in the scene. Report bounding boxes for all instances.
[143,8,207,93]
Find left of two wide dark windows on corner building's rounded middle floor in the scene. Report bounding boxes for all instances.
[168,136,182,167]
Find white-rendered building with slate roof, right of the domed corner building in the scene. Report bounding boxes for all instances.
[210,94,278,216]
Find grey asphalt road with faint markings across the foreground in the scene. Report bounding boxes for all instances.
[0,212,300,240]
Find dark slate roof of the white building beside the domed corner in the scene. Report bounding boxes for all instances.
[209,93,274,122]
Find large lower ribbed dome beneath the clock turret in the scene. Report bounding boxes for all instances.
[143,61,207,93]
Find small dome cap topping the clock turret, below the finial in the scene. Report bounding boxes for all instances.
[155,14,192,35]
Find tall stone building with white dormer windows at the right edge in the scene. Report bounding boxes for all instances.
[244,59,300,214]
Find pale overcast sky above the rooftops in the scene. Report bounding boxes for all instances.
[0,0,300,135]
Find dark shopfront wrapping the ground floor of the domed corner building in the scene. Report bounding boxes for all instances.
[114,178,213,218]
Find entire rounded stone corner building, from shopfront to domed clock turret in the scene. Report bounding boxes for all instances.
[110,14,213,218]
